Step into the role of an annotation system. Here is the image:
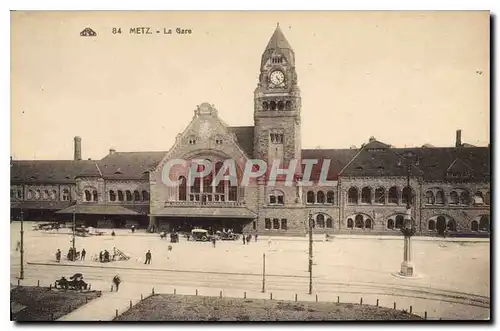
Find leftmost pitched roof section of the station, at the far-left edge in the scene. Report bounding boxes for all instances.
[10,160,95,184]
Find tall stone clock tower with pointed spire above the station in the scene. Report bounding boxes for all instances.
[254,24,301,170]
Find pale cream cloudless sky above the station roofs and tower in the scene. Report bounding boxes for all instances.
[11,11,490,159]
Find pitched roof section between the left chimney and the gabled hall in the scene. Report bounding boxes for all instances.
[80,151,167,179]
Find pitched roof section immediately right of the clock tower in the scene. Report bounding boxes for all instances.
[302,149,358,181]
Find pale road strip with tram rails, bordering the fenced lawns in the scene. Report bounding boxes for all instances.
[11,263,490,318]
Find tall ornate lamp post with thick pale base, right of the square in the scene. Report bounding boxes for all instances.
[399,155,418,277]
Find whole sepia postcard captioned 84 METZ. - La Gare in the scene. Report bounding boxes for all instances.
[10,11,491,322]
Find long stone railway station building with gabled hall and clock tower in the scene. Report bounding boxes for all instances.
[11,26,491,236]
